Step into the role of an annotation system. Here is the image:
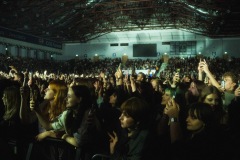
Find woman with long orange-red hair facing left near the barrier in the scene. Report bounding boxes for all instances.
[20,80,67,138]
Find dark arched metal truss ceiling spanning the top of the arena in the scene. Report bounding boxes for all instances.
[0,0,240,42]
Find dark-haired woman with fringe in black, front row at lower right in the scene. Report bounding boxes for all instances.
[164,102,226,160]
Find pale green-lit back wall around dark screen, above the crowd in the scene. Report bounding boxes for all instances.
[59,38,240,60]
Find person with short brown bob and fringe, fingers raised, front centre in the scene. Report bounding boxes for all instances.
[109,97,158,160]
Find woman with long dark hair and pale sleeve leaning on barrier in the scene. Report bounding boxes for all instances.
[31,85,106,159]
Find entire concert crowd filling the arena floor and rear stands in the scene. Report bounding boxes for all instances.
[0,54,240,160]
